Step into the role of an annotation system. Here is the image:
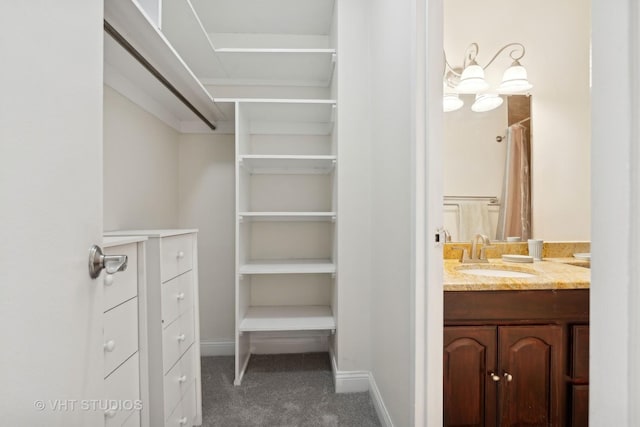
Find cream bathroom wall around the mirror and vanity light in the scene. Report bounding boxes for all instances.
[444,0,591,240]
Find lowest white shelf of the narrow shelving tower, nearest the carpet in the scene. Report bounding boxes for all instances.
[239,305,336,332]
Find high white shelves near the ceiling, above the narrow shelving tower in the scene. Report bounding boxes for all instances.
[162,0,336,87]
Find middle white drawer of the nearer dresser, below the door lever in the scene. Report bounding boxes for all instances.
[103,298,138,377]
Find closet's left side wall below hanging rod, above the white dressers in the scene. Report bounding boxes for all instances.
[103,86,179,231]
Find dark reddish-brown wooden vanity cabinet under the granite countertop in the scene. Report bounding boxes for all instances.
[443,290,589,427]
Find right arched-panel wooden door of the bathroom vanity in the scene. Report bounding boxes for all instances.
[498,325,562,427]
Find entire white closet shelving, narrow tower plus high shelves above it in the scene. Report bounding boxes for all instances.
[154,0,339,385]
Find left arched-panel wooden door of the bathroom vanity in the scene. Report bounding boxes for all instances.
[444,326,498,427]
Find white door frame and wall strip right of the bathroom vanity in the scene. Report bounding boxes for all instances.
[589,0,640,426]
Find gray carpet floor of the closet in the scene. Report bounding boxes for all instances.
[202,353,380,427]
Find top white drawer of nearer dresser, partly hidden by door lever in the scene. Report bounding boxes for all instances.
[100,243,138,311]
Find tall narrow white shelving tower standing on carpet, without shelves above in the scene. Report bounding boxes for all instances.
[235,99,338,384]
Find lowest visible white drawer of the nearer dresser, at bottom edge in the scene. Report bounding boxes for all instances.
[104,353,140,427]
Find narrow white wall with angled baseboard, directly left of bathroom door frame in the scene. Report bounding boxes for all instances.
[364,0,415,426]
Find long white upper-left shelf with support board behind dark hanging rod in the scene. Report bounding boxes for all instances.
[104,0,221,131]
